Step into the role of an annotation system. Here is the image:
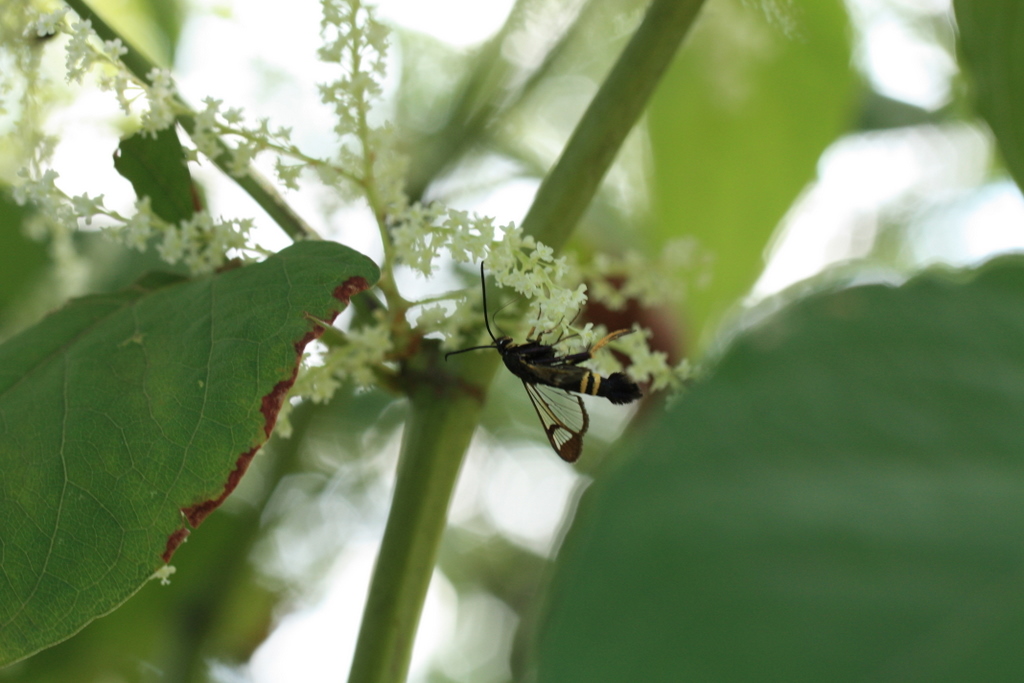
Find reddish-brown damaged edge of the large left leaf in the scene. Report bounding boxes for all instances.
[161,278,370,563]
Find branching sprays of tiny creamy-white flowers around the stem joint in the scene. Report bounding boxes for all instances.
[8,0,700,409]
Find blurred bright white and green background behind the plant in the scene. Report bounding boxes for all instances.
[0,0,1024,683]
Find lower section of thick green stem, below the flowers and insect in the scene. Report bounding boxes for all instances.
[348,343,497,683]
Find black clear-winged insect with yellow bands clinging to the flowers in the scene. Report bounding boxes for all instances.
[444,263,643,463]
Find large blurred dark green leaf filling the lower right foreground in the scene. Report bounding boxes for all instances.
[535,256,1024,683]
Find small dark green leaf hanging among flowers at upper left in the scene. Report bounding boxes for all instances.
[114,126,197,225]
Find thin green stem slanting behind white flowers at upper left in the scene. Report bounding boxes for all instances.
[66,0,319,240]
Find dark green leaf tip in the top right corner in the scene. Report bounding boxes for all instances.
[953,0,1024,192]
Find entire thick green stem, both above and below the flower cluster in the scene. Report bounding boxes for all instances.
[348,0,702,683]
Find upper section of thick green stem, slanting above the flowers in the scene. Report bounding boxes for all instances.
[522,0,703,251]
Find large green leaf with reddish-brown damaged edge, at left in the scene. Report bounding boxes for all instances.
[0,242,379,665]
